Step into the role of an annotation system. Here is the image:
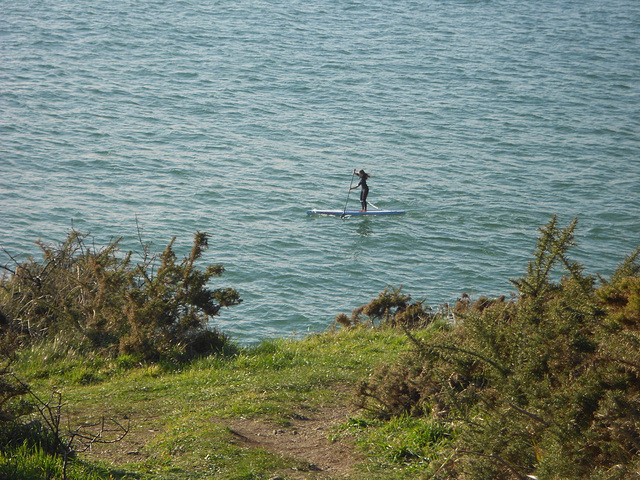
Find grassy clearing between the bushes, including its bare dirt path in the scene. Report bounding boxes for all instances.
[5,327,444,479]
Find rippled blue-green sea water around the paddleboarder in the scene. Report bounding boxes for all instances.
[0,0,640,342]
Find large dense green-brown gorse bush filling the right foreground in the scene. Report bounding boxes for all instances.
[359,217,640,479]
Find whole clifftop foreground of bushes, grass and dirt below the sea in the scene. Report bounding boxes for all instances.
[0,217,640,480]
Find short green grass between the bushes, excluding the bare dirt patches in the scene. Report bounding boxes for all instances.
[8,328,450,480]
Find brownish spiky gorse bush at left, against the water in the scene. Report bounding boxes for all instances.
[0,231,241,360]
